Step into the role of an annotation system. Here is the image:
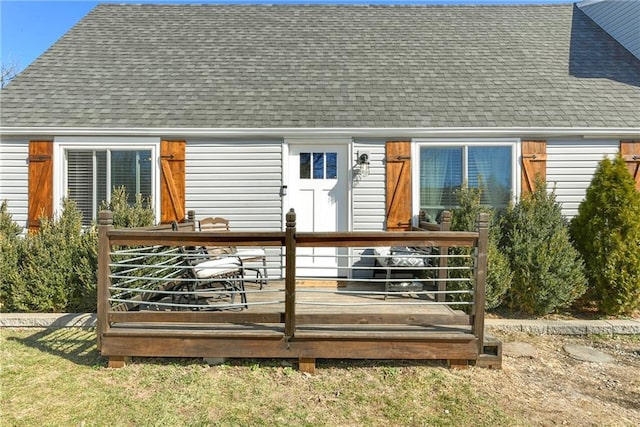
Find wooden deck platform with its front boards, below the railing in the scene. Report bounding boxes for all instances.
[102,281,479,366]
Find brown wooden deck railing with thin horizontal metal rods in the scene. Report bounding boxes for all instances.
[97,210,488,352]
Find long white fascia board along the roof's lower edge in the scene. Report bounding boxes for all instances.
[0,127,640,139]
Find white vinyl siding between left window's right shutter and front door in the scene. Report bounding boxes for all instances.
[185,140,283,278]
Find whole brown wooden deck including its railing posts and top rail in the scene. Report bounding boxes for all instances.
[98,210,500,372]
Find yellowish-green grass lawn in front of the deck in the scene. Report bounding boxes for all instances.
[0,329,527,427]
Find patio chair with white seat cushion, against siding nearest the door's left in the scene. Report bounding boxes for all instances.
[200,217,268,289]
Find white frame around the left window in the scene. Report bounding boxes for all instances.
[53,137,161,223]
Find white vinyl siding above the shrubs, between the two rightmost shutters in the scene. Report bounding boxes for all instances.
[547,140,619,218]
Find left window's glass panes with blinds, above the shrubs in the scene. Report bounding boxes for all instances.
[66,149,153,225]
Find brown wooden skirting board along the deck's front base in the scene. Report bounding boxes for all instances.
[102,328,478,360]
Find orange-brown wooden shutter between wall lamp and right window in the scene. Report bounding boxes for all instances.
[386,141,412,231]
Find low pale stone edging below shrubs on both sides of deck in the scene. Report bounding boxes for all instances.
[0,313,640,335]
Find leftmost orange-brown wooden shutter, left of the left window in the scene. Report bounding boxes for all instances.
[27,141,53,232]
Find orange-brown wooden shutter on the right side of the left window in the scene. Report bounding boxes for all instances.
[160,141,186,224]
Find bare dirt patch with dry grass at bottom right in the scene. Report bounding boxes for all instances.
[476,333,640,426]
